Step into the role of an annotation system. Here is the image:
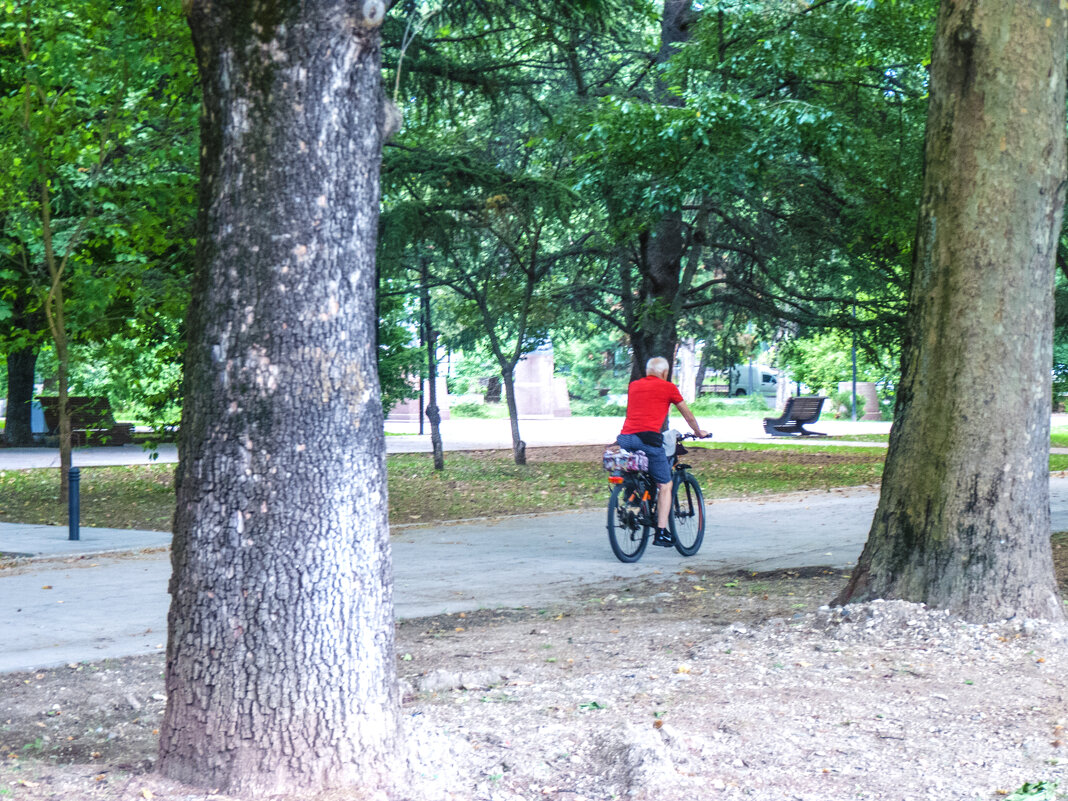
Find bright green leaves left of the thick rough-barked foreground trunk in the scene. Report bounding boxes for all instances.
[0,0,199,427]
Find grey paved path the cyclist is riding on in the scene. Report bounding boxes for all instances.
[6,476,1068,671]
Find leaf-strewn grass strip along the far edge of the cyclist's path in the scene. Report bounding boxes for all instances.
[0,452,1068,531]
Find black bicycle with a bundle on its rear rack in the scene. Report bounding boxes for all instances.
[606,434,711,562]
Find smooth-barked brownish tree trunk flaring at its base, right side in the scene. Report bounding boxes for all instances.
[838,0,1065,621]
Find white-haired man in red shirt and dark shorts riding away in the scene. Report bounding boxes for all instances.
[615,356,708,547]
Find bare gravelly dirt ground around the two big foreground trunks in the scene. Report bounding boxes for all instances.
[0,559,1068,801]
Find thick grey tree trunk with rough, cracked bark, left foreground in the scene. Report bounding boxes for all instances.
[158,0,398,796]
